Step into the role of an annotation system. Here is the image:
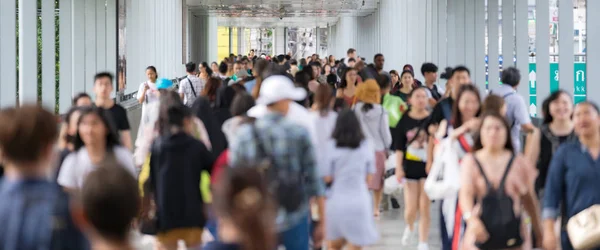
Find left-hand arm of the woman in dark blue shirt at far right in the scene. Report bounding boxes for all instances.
[542,147,568,249]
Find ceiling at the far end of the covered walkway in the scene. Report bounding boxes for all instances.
[187,0,379,28]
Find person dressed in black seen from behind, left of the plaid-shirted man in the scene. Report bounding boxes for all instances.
[142,95,214,250]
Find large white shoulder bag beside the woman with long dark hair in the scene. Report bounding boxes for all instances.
[424,138,460,200]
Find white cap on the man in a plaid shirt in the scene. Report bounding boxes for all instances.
[256,75,306,105]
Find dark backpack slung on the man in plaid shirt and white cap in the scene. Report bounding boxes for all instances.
[252,125,306,212]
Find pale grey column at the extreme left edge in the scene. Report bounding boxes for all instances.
[0,0,17,107]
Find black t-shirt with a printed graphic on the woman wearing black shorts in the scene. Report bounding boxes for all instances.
[394,114,429,169]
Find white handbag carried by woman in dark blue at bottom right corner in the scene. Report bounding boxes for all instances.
[567,205,600,250]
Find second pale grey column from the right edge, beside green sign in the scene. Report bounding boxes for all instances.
[558,0,576,94]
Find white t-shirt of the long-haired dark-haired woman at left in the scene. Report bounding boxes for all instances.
[58,146,136,189]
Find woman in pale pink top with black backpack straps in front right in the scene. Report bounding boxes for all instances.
[458,113,542,249]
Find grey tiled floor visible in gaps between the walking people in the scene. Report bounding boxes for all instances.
[135,203,441,250]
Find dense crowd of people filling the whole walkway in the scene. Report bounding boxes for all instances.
[0,49,600,250]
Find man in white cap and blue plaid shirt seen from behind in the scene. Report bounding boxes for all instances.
[230,75,324,250]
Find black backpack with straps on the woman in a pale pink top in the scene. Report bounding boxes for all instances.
[474,154,523,249]
